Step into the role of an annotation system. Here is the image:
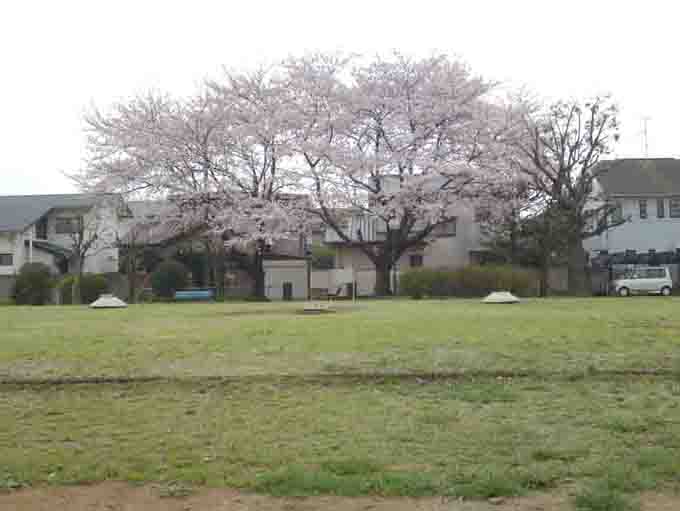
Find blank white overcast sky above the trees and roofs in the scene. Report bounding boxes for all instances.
[0,0,680,195]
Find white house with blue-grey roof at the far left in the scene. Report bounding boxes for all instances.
[0,194,129,298]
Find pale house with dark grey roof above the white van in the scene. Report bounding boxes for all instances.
[584,158,680,256]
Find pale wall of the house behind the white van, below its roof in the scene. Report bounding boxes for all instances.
[584,197,680,253]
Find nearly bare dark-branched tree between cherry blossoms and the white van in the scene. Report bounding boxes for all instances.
[508,96,623,294]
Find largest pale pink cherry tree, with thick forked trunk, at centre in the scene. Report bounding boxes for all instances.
[288,54,510,295]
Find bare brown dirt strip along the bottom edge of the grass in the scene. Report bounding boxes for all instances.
[0,482,680,511]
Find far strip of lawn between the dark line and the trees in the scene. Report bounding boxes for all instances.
[0,298,680,378]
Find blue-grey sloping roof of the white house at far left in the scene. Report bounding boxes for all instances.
[0,193,97,232]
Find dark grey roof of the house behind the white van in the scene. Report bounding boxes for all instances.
[598,158,680,196]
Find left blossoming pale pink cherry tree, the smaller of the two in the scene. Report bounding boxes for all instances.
[75,77,301,296]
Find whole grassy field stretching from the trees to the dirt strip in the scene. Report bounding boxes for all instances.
[0,298,680,509]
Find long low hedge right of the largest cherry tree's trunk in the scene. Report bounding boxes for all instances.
[399,265,536,299]
